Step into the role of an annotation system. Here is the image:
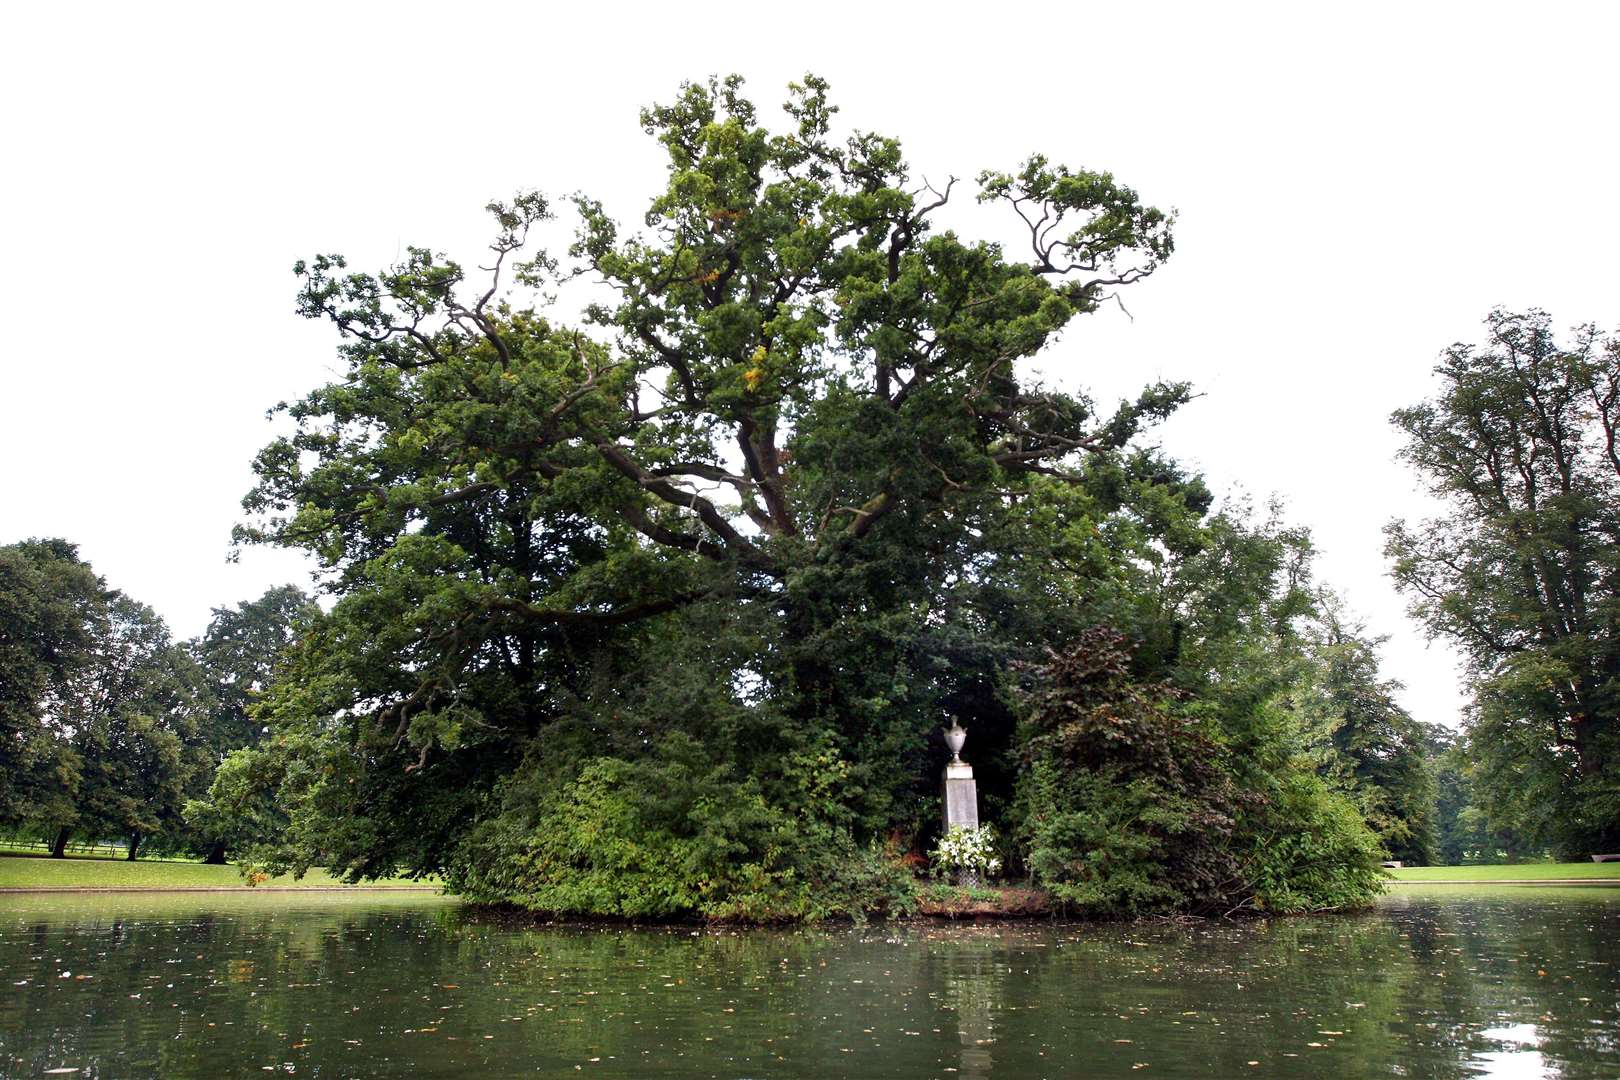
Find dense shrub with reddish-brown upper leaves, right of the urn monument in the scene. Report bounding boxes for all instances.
[1016,628,1379,915]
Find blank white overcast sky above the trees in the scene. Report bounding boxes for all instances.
[0,0,1620,722]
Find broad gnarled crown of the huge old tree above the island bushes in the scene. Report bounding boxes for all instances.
[234,78,1186,854]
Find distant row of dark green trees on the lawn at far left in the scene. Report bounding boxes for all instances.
[0,539,313,863]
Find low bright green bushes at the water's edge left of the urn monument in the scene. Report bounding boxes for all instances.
[447,737,914,923]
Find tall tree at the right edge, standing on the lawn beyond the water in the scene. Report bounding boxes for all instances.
[1387,311,1620,852]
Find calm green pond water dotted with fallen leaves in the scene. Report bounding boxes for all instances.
[0,887,1620,1080]
